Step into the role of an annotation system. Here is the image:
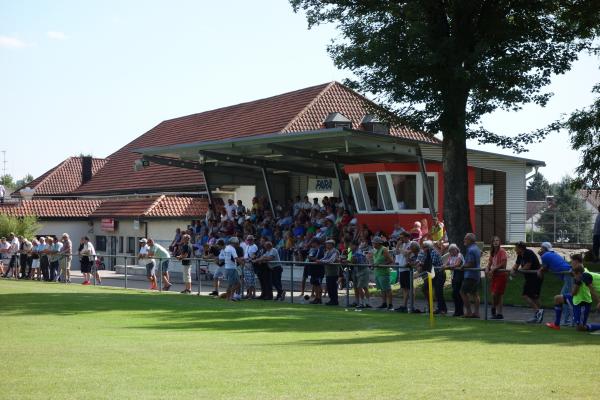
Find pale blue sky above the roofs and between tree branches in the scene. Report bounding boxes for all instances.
[0,0,600,182]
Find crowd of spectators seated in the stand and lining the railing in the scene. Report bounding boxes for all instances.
[0,197,600,330]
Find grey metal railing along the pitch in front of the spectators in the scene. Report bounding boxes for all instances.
[6,255,570,320]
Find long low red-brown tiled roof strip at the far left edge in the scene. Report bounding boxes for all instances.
[0,199,102,218]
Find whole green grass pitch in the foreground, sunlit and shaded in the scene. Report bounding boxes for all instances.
[0,280,600,399]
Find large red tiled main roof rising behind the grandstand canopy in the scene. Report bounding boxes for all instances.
[75,82,436,194]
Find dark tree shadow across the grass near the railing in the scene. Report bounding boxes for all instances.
[0,289,599,346]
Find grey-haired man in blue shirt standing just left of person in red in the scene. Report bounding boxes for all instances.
[460,233,481,318]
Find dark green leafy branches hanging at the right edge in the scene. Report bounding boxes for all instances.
[566,84,600,190]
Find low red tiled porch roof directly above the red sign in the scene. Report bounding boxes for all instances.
[91,196,208,218]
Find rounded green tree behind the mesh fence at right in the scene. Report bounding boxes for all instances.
[537,178,593,243]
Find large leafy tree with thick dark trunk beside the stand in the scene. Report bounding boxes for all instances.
[290,0,600,243]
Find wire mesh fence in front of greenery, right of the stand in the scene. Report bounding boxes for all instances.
[508,211,598,245]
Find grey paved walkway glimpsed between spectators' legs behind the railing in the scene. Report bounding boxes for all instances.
[15,271,580,323]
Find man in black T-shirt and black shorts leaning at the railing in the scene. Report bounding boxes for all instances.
[511,242,544,324]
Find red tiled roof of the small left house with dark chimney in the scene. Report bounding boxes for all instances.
[15,157,106,196]
